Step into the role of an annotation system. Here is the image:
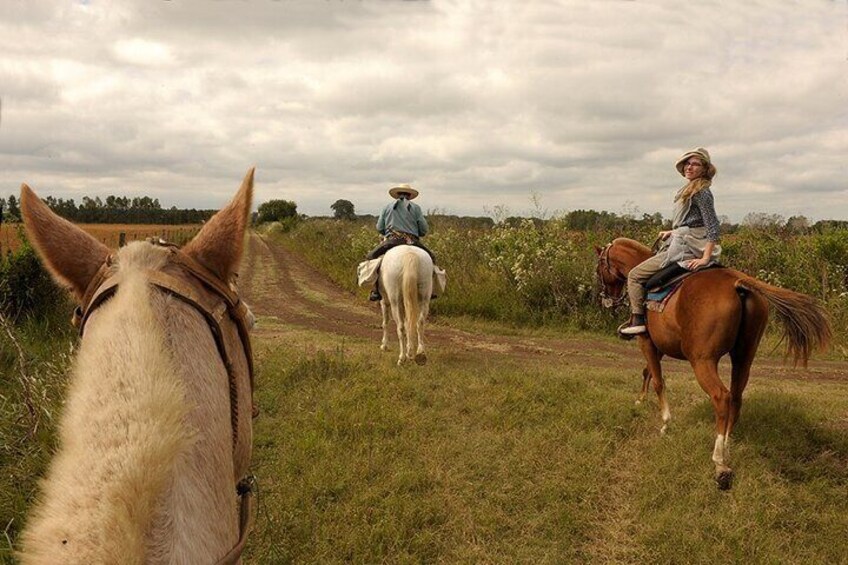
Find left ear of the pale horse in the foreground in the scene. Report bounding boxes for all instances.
[21,184,110,300]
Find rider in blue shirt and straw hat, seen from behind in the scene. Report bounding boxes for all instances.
[367,184,436,302]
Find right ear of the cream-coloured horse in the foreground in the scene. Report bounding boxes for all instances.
[183,167,256,282]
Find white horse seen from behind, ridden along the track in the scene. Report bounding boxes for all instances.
[379,245,433,365]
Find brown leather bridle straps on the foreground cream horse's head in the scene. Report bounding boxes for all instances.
[73,238,256,565]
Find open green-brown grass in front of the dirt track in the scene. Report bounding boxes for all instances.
[243,320,848,563]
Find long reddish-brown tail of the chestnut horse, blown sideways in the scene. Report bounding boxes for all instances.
[735,276,833,366]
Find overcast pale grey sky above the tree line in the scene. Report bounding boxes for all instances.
[0,0,848,221]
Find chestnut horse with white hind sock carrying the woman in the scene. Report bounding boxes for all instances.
[595,238,832,489]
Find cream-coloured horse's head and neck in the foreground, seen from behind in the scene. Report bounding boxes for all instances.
[20,169,253,564]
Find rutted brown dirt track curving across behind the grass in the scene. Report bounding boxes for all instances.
[240,233,848,380]
